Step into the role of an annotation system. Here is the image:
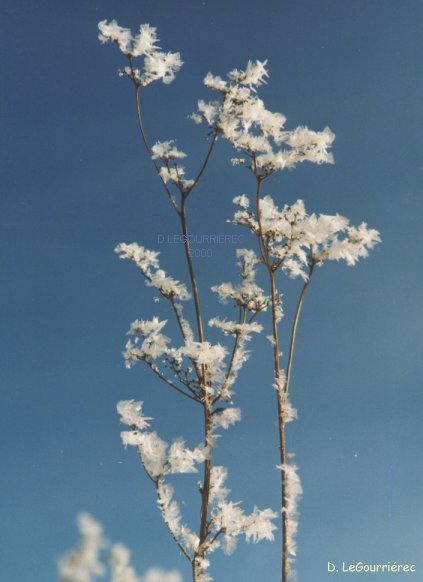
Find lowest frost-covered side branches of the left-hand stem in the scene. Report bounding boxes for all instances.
[117,400,278,580]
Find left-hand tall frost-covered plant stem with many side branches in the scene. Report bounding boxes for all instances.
[99,21,278,582]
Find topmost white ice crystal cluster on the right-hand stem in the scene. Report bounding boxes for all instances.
[192,61,335,177]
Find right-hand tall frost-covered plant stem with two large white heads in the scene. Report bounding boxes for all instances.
[192,61,380,582]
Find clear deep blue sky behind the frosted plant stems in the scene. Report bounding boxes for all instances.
[0,0,423,582]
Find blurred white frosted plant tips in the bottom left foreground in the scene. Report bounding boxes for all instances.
[58,513,182,582]
